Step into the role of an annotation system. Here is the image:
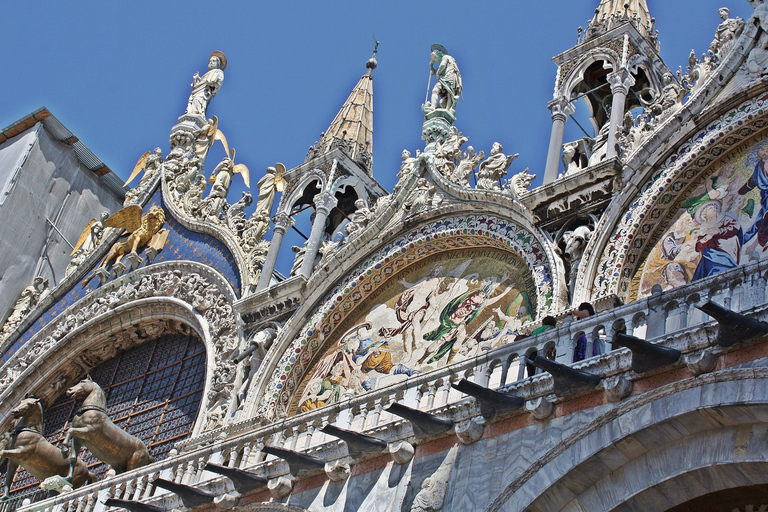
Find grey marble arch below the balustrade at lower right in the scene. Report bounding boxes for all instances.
[486,368,768,512]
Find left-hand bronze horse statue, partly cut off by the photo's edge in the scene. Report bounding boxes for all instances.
[0,397,96,499]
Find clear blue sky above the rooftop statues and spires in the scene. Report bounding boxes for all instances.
[0,0,752,278]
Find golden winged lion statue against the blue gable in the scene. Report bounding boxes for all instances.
[83,205,169,286]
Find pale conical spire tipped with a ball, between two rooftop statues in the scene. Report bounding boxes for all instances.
[305,41,379,174]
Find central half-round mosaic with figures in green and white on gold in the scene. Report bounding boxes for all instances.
[297,249,536,412]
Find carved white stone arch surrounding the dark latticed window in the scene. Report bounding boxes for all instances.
[0,262,239,434]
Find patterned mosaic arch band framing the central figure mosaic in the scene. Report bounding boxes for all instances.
[255,212,560,418]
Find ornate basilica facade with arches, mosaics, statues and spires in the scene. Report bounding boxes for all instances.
[0,0,768,512]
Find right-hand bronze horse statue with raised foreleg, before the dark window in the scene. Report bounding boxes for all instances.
[61,377,155,473]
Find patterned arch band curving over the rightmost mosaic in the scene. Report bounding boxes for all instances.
[577,93,768,300]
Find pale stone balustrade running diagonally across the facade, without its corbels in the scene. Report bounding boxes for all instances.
[18,262,768,512]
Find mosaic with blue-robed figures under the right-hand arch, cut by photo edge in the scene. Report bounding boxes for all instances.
[635,136,768,298]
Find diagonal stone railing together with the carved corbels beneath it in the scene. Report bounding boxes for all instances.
[18,262,768,512]
